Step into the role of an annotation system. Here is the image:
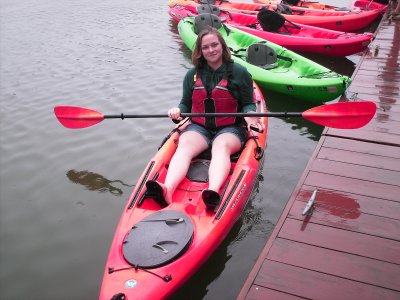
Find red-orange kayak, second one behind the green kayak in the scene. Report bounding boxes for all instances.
[168,0,383,32]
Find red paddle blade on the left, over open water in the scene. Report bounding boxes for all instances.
[54,106,104,129]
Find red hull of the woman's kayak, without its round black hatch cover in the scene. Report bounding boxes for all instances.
[99,85,268,300]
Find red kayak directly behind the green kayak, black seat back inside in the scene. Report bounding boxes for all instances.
[169,5,374,56]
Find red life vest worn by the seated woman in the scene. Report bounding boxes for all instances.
[191,68,239,129]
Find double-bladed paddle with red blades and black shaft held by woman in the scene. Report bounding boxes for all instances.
[54,101,376,129]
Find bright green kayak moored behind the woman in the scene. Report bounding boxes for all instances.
[178,14,351,103]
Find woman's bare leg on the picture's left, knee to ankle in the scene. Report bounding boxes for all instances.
[164,131,208,203]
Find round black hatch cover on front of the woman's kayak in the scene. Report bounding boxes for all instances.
[122,210,193,268]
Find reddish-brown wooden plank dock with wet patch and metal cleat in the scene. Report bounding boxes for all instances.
[238,10,400,300]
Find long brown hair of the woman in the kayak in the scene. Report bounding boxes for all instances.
[192,26,231,68]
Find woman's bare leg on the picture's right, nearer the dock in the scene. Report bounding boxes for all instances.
[208,133,241,193]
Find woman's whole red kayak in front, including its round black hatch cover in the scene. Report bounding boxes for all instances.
[100,85,268,300]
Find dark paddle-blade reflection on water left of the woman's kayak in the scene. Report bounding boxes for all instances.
[67,170,134,196]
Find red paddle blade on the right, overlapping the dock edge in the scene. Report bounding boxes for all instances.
[302,101,376,129]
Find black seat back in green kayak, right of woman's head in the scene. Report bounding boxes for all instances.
[247,43,278,70]
